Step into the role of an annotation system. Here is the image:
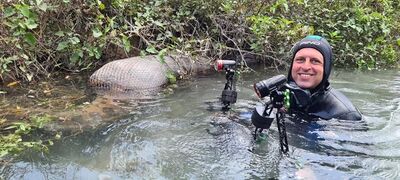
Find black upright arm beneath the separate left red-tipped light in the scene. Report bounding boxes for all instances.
[221,68,237,110]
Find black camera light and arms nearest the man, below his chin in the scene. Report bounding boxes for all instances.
[251,75,311,153]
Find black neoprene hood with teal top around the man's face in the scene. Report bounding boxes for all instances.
[288,35,333,90]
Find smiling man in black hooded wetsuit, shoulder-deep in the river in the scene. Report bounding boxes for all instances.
[288,35,362,120]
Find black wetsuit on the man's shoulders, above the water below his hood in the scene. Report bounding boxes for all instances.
[292,87,362,120]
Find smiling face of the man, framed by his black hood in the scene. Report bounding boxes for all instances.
[291,48,324,89]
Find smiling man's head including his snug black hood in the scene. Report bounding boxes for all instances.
[288,35,333,91]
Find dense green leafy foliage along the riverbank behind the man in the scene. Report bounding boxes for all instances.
[0,0,400,81]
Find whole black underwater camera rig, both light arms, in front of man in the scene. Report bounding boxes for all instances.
[214,60,311,153]
